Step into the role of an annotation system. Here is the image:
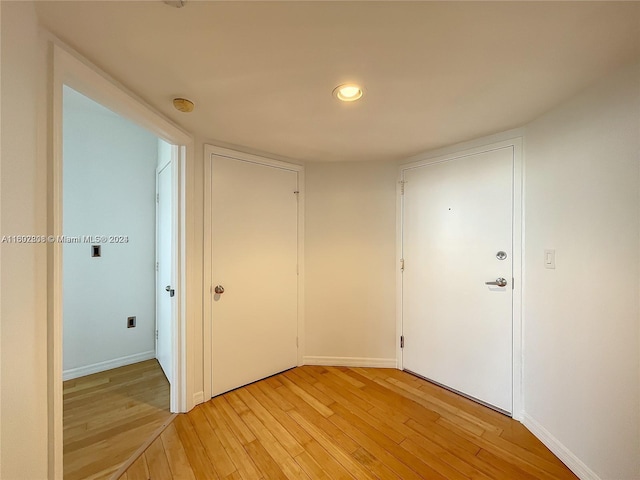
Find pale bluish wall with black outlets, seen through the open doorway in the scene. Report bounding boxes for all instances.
[63,87,158,379]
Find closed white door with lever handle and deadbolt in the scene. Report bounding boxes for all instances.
[402,146,514,413]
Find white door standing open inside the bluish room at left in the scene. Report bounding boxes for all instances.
[156,162,175,383]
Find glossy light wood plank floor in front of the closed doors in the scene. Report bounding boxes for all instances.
[120,366,577,480]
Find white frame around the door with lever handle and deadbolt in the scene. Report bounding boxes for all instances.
[396,136,524,421]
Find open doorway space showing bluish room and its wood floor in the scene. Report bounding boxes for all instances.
[56,85,176,479]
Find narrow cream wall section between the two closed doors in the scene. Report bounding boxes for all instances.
[305,162,397,366]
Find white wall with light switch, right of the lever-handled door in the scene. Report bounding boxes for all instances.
[524,65,640,480]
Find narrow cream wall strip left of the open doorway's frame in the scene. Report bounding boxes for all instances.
[0,2,48,480]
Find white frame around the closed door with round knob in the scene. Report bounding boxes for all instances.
[202,145,305,401]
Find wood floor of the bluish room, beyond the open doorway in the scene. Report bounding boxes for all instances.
[63,360,171,480]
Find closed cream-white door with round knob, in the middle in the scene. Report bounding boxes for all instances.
[211,155,298,395]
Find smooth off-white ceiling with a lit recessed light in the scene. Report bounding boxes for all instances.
[37,0,640,161]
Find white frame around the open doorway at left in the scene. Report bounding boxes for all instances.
[47,43,194,479]
